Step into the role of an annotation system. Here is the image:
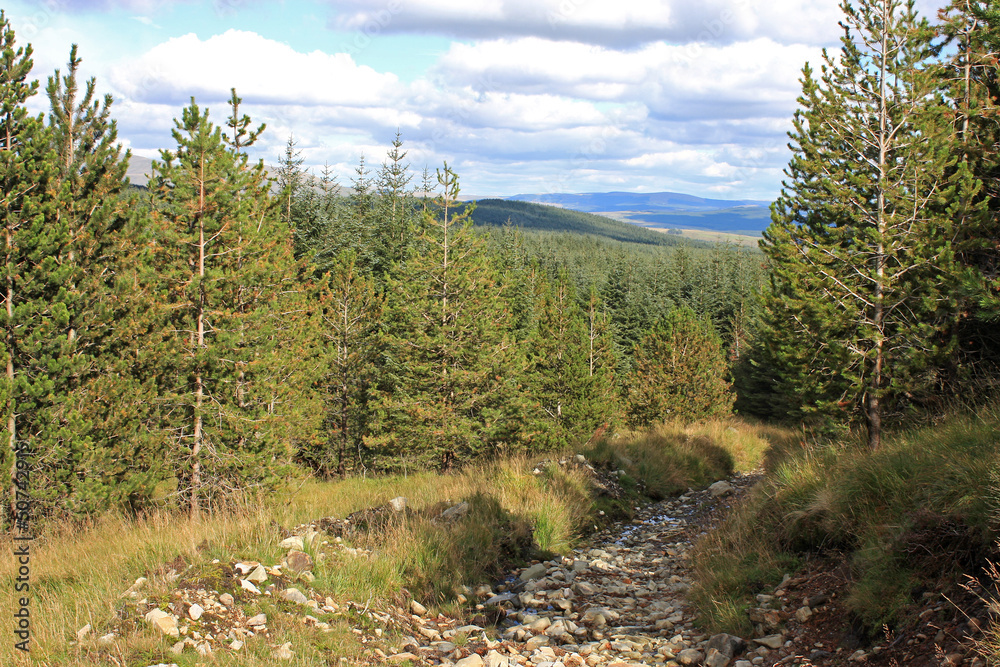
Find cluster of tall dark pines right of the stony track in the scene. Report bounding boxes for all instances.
[738,0,1000,448]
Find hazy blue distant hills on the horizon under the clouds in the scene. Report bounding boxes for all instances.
[509,192,771,236]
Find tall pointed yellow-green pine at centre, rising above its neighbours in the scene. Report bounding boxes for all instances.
[370,164,514,469]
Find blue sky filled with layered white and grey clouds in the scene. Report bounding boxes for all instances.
[0,0,944,199]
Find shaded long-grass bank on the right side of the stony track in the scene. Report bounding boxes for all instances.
[693,410,1000,636]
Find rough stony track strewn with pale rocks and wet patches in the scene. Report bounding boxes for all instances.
[378,475,760,667]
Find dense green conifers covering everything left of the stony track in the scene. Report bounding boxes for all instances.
[0,13,761,520]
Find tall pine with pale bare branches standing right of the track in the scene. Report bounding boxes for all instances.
[762,0,960,448]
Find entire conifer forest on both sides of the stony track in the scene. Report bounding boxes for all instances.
[0,0,1000,519]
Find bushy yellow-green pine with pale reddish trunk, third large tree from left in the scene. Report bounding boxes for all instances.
[151,100,311,517]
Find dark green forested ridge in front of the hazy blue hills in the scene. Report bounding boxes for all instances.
[472,199,681,246]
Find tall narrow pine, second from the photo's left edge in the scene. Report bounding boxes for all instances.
[40,45,141,513]
